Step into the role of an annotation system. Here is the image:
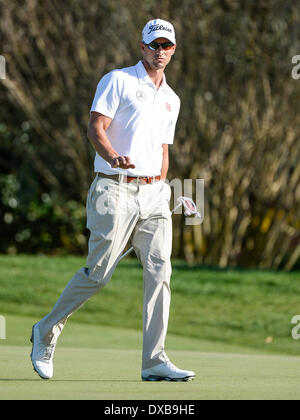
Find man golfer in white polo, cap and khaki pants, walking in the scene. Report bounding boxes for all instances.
[31,19,195,381]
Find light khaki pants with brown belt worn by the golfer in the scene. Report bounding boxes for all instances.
[39,176,172,369]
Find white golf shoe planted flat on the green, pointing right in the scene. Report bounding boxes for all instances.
[142,361,196,382]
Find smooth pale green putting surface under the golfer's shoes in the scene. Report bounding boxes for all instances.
[0,315,300,400]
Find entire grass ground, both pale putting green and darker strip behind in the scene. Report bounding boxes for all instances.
[0,256,300,400]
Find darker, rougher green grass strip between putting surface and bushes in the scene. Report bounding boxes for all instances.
[0,256,300,355]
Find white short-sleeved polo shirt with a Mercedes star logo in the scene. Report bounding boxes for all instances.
[91,61,180,176]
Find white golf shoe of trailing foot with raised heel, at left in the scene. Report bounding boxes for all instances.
[30,324,55,379]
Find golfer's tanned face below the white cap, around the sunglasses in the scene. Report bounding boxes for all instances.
[140,38,176,70]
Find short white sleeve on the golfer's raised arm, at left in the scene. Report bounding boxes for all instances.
[90,71,121,119]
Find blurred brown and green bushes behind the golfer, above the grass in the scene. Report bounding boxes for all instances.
[0,0,300,270]
